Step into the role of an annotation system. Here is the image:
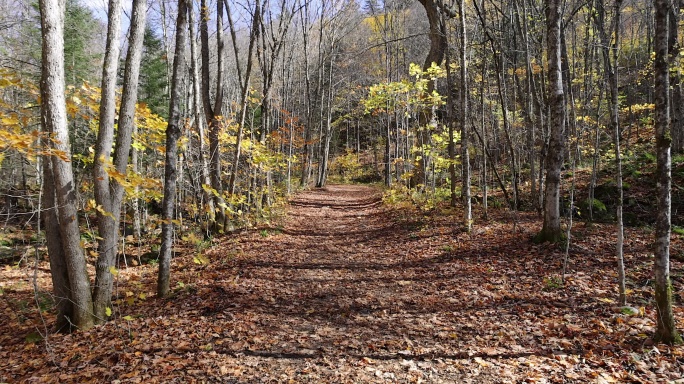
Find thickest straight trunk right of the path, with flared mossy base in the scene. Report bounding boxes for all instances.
[537,0,565,242]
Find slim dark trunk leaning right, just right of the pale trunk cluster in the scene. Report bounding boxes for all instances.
[157,0,188,297]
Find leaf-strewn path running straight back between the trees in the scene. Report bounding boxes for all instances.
[202,186,550,383]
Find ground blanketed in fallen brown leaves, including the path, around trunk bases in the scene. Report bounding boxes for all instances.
[0,185,684,383]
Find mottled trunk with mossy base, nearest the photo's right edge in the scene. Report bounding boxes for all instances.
[653,0,682,344]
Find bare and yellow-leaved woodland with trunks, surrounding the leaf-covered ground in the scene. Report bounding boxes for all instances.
[0,0,684,378]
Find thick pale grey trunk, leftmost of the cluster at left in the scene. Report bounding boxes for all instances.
[39,0,94,330]
